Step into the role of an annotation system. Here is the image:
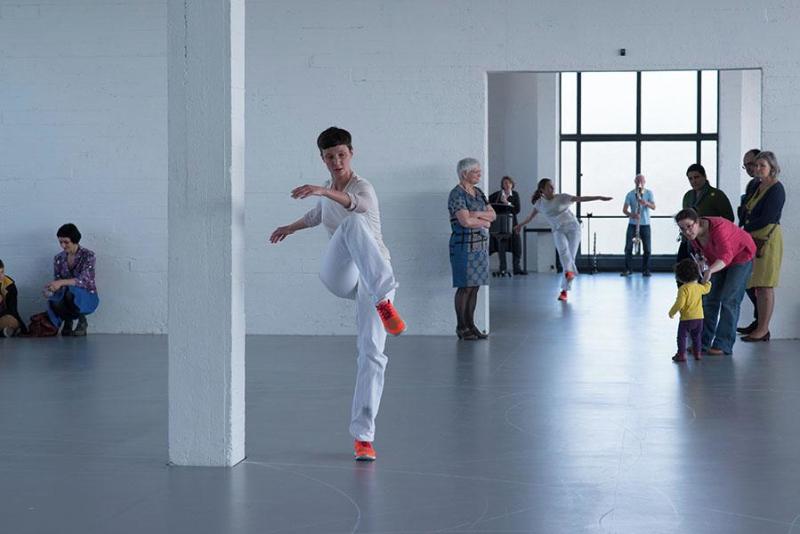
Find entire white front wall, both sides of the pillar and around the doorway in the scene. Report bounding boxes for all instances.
[0,0,800,337]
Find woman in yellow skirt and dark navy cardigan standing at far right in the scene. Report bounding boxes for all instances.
[742,151,786,341]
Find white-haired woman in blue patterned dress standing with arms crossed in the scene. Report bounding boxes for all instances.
[447,158,496,340]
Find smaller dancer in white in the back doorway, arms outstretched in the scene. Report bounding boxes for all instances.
[514,178,611,302]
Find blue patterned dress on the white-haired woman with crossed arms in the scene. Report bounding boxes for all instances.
[447,185,489,287]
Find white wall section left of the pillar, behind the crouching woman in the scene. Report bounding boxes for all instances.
[0,0,167,332]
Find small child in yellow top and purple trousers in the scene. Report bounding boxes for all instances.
[669,258,711,362]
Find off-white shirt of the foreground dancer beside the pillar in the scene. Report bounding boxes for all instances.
[303,174,389,261]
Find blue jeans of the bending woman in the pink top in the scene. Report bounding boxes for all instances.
[703,260,753,354]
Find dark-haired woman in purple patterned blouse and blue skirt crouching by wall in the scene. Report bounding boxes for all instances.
[42,223,100,336]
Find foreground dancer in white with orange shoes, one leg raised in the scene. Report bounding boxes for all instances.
[269,127,406,461]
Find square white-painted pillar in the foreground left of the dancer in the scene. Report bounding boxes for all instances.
[167,0,245,466]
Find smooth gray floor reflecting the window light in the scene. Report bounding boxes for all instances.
[0,274,800,534]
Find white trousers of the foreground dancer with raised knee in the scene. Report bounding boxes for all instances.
[319,213,397,441]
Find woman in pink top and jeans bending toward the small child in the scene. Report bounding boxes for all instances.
[675,208,756,356]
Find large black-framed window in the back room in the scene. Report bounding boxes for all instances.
[560,71,718,262]
